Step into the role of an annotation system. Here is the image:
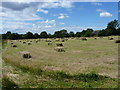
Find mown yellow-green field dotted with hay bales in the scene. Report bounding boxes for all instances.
[2,36,118,88]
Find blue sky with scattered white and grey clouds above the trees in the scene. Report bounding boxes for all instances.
[0,0,118,34]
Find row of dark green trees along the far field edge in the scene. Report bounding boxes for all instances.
[2,20,120,40]
